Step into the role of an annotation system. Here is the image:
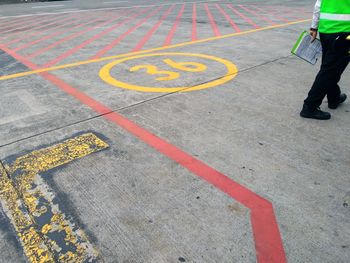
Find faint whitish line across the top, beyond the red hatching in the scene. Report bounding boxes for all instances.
[0,0,220,19]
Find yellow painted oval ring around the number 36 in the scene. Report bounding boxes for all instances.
[99,52,238,92]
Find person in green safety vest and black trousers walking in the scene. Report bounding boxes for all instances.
[300,0,350,120]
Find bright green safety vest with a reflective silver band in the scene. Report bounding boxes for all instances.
[318,0,350,34]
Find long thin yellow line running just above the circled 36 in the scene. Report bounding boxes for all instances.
[0,19,311,81]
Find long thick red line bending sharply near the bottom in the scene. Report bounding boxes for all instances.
[0,45,287,263]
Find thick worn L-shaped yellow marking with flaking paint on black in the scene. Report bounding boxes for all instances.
[0,133,108,263]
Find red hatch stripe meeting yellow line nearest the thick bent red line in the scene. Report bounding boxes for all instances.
[43,8,146,67]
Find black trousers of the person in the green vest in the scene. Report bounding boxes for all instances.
[304,33,350,108]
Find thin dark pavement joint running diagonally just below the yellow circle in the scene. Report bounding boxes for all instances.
[0,55,293,148]
